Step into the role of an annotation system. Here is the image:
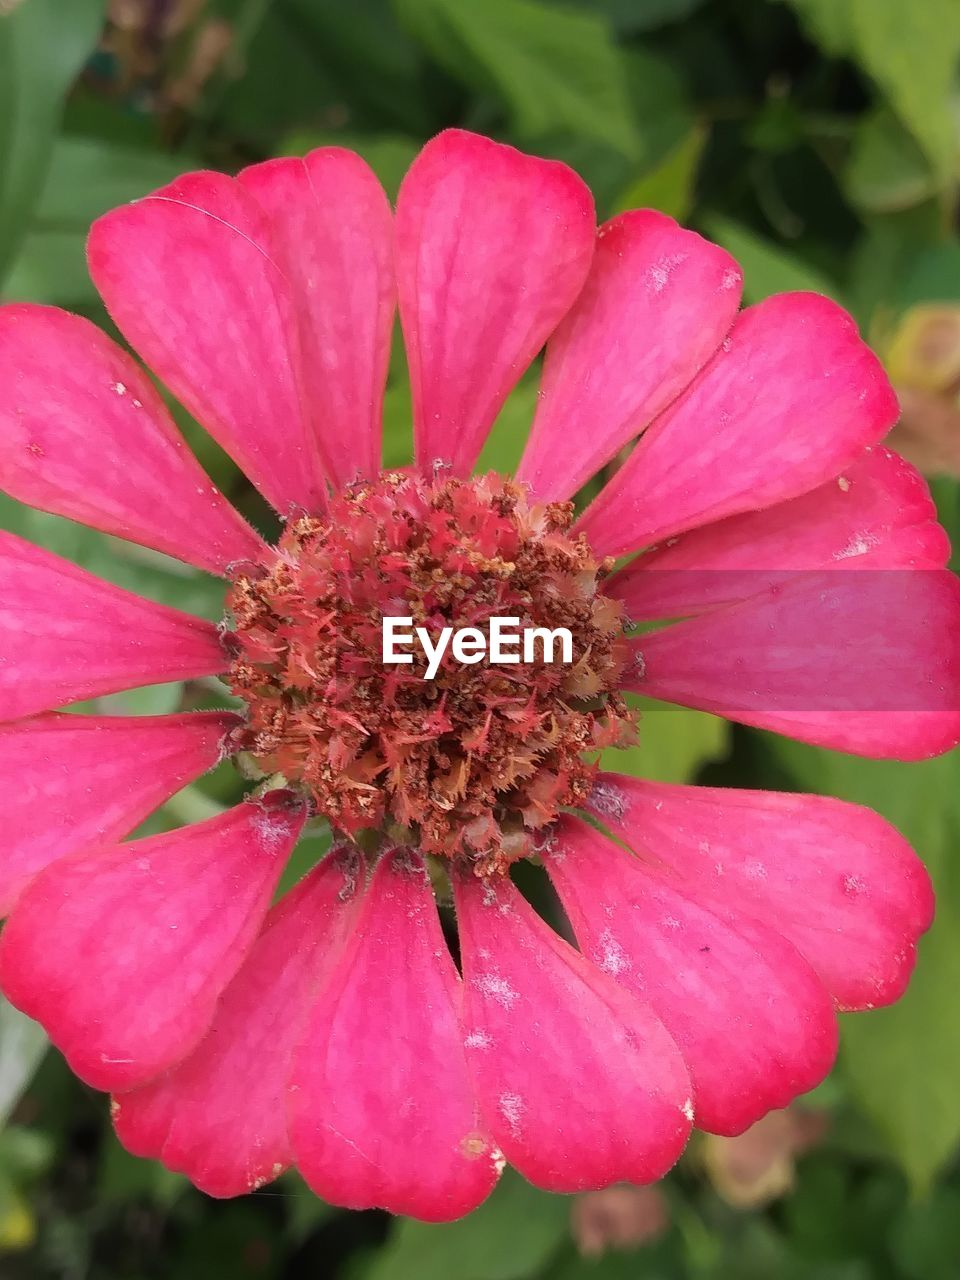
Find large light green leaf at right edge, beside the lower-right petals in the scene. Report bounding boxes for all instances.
[767,737,960,1192]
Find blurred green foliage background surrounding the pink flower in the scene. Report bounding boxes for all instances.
[0,0,960,1280]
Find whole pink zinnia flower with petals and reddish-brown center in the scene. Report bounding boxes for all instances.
[0,131,960,1220]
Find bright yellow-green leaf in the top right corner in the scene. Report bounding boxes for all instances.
[847,0,960,182]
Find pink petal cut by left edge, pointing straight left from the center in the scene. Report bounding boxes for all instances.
[0,532,227,719]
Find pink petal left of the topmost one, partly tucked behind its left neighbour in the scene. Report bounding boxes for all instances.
[238,147,396,485]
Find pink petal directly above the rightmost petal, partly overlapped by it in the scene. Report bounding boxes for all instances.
[607,445,950,621]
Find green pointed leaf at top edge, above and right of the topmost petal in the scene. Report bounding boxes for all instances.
[394,0,640,156]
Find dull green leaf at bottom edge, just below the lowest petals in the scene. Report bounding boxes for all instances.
[367,1171,570,1280]
